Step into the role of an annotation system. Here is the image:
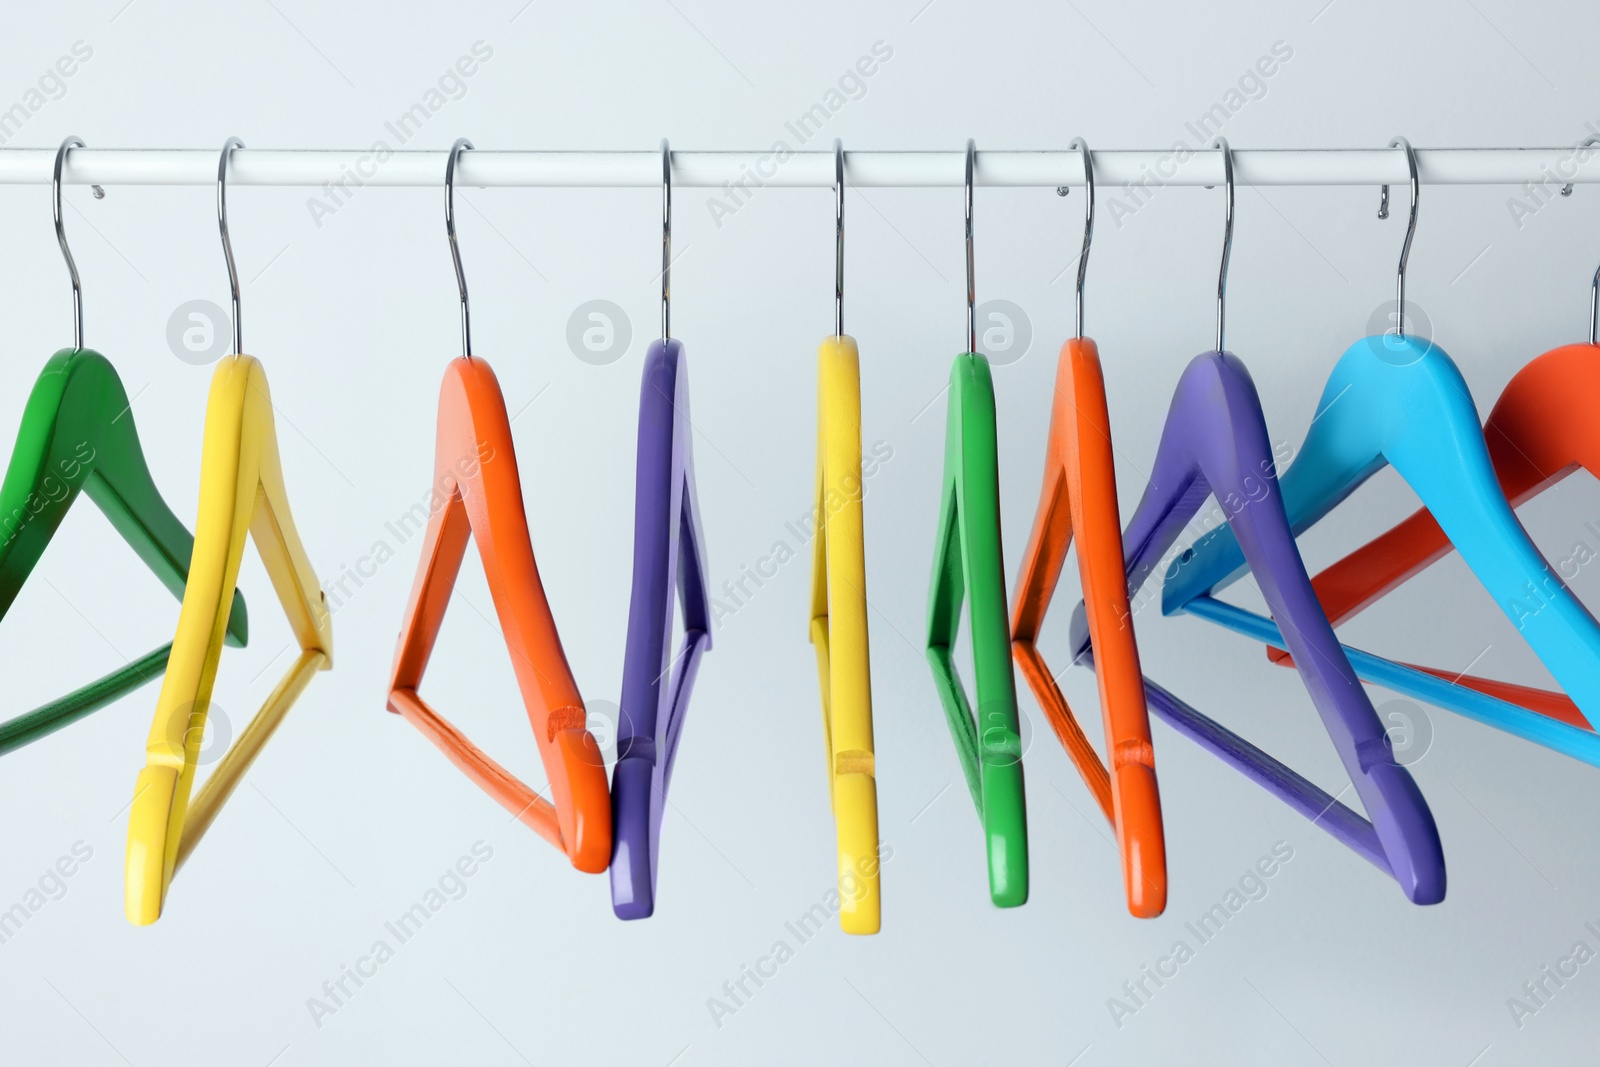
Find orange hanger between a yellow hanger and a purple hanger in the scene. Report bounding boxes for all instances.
[389,138,611,873]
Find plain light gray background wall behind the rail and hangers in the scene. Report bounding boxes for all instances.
[0,0,1600,1067]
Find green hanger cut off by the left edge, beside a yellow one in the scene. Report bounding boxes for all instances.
[0,138,248,755]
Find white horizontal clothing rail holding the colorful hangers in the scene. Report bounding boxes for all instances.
[0,146,1600,189]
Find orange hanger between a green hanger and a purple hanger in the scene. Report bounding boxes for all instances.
[1011,138,1166,918]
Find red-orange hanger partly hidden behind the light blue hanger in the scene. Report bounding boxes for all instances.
[1269,235,1600,733]
